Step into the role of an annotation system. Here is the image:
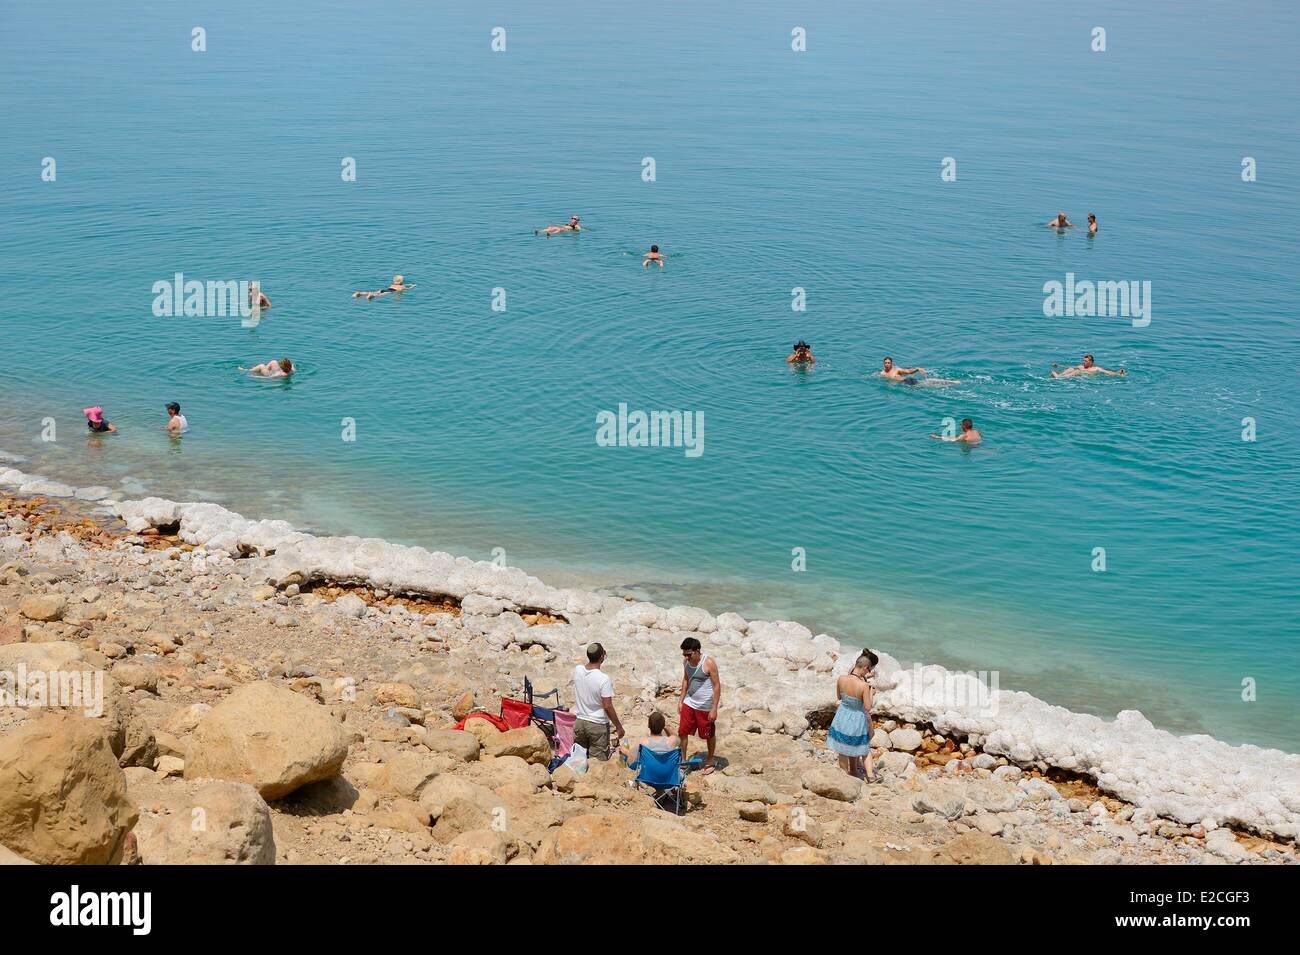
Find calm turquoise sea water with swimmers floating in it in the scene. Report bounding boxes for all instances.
[0,0,1300,751]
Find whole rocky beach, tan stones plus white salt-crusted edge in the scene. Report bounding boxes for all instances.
[0,468,1300,865]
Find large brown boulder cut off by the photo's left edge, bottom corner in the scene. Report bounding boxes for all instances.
[0,712,138,865]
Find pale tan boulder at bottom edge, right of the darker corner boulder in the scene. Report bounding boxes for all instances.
[135,780,276,865]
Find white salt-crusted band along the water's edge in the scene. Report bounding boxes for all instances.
[0,454,1300,841]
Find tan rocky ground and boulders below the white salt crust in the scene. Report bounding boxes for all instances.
[0,485,1300,865]
